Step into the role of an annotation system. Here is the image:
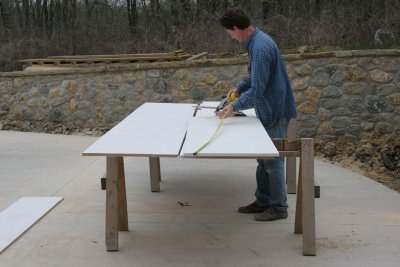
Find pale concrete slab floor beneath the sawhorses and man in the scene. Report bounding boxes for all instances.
[0,131,400,267]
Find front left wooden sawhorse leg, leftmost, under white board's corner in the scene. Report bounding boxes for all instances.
[106,157,119,251]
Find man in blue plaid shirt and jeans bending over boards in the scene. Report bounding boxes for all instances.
[218,8,297,221]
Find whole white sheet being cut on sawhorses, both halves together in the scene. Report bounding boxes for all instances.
[83,102,279,158]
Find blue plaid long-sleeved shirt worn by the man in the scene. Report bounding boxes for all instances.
[232,28,297,129]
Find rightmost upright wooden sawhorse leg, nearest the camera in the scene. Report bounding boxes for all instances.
[301,138,316,256]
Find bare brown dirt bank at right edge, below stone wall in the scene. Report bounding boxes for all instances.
[316,131,400,192]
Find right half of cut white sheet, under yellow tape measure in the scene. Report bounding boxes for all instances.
[181,109,279,158]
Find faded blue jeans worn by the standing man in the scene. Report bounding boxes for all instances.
[255,118,289,211]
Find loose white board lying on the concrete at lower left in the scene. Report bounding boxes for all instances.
[0,197,63,254]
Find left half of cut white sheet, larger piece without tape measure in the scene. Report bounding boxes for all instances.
[83,103,194,156]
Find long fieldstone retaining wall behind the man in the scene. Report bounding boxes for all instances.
[0,50,400,144]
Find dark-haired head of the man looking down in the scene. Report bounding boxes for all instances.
[219,7,252,42]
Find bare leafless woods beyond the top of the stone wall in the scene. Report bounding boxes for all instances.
[0,0,400,71]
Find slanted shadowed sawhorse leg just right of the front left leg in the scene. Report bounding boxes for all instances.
[118,157,129,231]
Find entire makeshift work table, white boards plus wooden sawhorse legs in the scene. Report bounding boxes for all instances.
[83,103,316,255]
